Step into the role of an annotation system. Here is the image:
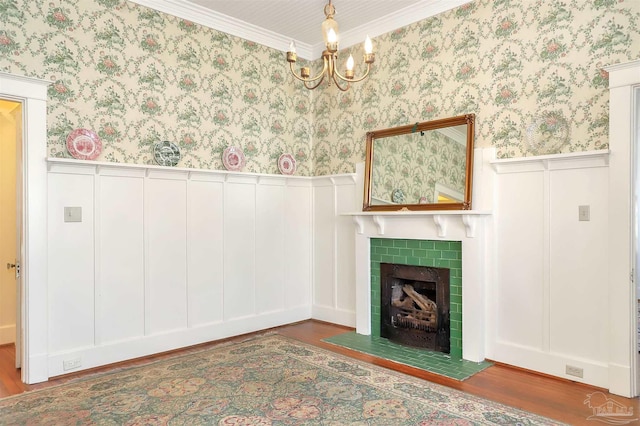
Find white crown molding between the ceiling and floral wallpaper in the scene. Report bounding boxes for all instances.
[130,0,470,60]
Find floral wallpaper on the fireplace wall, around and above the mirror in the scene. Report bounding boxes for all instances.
[313,0,640,175]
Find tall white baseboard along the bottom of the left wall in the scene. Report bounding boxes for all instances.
[46,306,311,381]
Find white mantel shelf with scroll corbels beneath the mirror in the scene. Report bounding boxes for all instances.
[342,210,491,238]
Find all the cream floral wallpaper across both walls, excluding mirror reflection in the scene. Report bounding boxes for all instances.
[0,0,640,175]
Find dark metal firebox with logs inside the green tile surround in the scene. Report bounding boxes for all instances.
[380,263,450,353]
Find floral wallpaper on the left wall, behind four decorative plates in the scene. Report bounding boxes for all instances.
[0,0,312,175]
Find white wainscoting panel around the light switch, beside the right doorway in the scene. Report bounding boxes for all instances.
[549,167,610,363]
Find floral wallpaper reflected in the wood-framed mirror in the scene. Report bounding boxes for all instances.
[371,131,467,204]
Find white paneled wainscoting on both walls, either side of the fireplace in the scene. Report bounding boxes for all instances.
[41,149,611,387]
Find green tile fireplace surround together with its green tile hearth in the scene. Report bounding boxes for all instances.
[326,238,491,380]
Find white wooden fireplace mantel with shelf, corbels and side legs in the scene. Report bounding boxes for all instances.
[342,210,492,362]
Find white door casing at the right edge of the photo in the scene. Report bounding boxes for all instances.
[605,60,640,397]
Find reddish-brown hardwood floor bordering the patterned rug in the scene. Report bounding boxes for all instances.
[0,320,640,425]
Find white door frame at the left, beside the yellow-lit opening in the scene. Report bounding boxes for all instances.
[0,72,51,384]
